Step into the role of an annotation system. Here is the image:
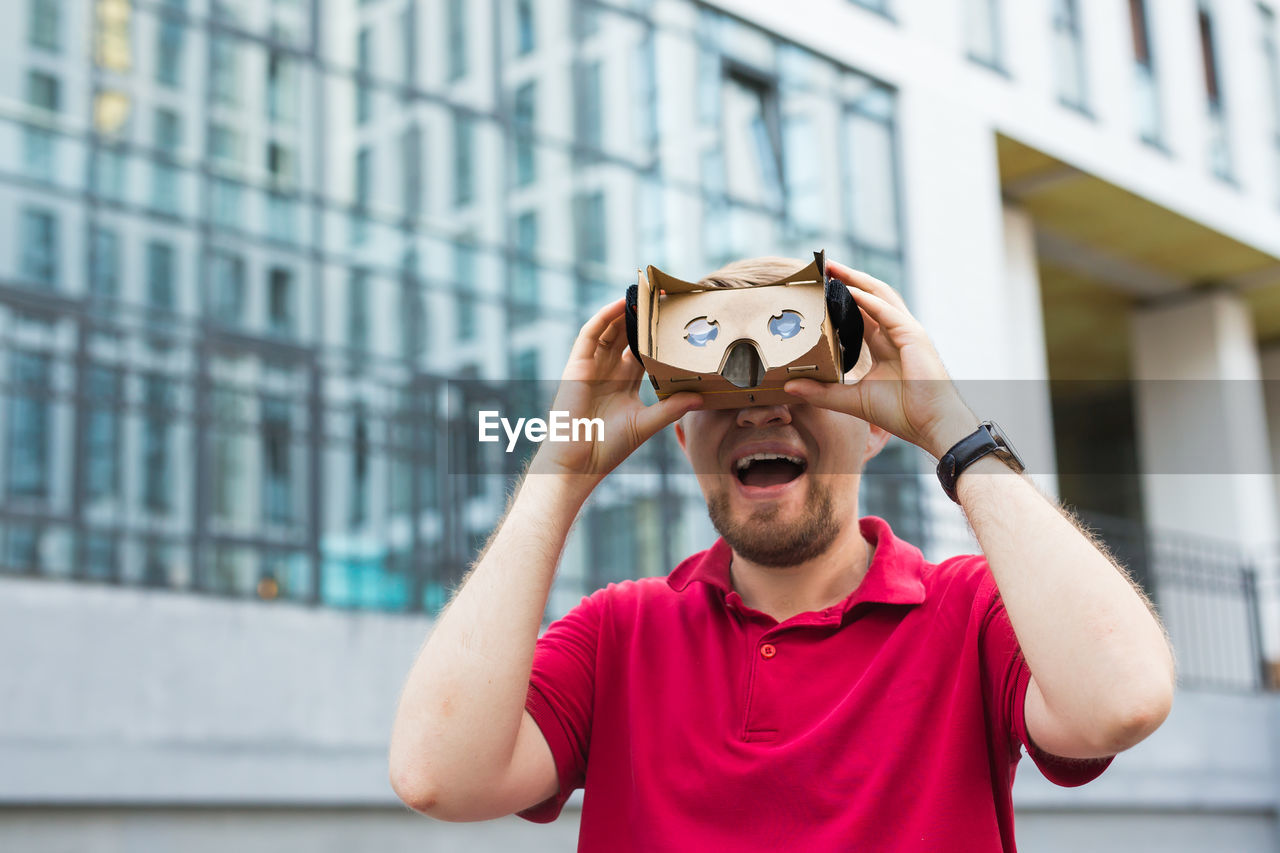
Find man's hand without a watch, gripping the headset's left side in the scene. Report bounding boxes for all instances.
[529,298,703,498]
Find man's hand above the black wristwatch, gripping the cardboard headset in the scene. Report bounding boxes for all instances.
[786,261,978,459]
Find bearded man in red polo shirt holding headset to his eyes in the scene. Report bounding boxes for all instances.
[390,259,1175,850]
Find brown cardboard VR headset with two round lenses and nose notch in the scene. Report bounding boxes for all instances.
[626,251,870,409]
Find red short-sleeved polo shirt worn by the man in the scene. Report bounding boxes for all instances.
[520,517,1111,853]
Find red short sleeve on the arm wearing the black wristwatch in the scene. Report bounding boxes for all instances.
[982,581,1115,788]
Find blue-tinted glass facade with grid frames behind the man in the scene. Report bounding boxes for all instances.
[0,0,916,612]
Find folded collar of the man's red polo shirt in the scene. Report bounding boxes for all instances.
[667,515,924,613]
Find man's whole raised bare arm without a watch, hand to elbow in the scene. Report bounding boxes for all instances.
[389,300,701,821]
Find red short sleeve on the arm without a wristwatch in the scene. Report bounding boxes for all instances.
[517,590,604,824]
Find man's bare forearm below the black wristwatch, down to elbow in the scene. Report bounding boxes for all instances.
[957,456,1175,743]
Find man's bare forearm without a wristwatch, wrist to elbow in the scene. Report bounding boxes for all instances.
[390,474,585,803]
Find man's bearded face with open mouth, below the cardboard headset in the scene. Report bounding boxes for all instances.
[676,403,888,567]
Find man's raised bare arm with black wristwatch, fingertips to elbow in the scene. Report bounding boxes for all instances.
[786,261,1175,758]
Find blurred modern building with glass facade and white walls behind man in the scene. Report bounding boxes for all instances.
[0,0,1280,852]
